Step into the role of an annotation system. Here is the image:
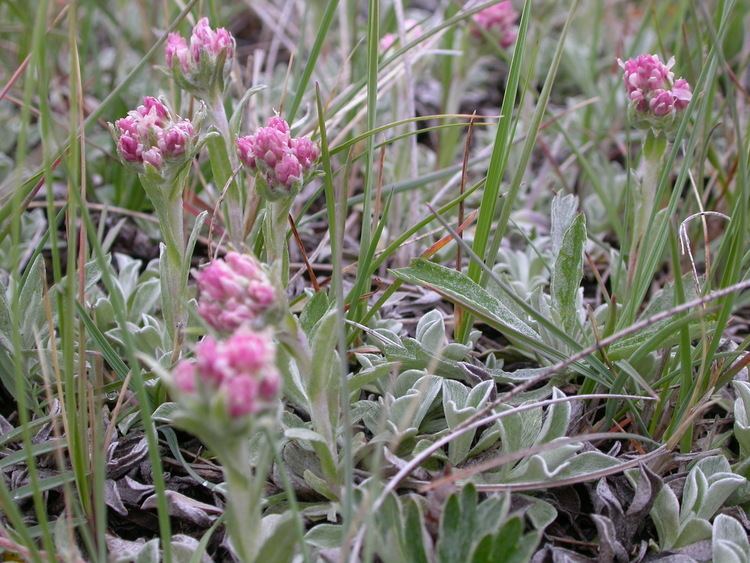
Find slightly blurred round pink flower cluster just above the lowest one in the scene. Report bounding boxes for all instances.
[195,252,276,332]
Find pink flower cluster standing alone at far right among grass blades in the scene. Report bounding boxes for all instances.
[617,55,693,117]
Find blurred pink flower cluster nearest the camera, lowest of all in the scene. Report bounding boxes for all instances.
[172,327,281,418]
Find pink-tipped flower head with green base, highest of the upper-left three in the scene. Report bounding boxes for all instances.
[164,18,235,99]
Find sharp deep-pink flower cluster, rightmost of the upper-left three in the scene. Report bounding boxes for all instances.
[237,116,318,194]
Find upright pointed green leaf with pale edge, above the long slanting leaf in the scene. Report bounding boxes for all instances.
[550,213,586,334]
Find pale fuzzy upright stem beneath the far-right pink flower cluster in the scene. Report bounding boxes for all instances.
[628,131,669,282]
